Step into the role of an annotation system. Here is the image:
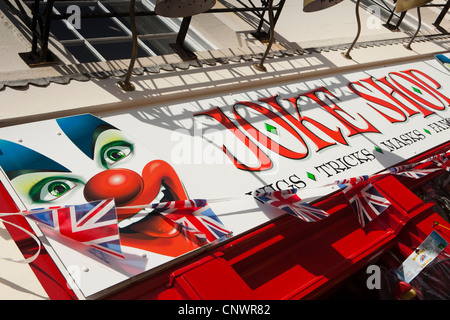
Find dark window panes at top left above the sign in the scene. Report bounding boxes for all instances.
[27,0,210,63]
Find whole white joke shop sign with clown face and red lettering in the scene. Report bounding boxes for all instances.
[0,55,450,297]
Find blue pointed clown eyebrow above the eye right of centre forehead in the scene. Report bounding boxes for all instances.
[56,114,119,159]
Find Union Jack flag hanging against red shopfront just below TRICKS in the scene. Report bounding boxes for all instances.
[337,176,391,228]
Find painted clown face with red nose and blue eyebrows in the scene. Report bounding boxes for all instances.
[0,114,198,257]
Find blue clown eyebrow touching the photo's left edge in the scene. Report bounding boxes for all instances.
[0,139,71,180]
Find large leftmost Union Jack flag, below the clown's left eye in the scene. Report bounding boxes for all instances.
[25,199,124,259]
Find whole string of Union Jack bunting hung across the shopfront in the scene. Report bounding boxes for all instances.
[0,151,450,263]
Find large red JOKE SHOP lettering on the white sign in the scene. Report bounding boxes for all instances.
[194,69,450,171]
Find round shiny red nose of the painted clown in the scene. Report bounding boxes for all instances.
[84,169,144,207]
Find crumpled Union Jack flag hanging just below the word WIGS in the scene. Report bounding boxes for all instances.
[255,189,329,222]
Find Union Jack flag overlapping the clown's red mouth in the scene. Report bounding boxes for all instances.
[152,199,231,244]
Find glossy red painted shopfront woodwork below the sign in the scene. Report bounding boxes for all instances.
[1,143,450,300]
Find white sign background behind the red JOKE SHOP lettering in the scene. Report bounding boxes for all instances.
[103,59,450,234]
